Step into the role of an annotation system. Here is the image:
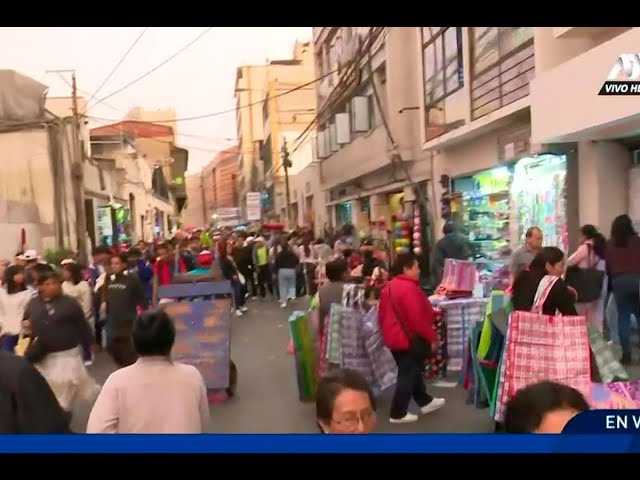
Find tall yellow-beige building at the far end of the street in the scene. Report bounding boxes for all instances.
[236,42,315,221]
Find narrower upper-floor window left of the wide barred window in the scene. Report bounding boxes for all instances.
[422,27,464,106]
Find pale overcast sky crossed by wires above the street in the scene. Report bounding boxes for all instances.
[0,27,312,173]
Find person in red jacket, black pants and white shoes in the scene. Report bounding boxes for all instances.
[378,253,445,423]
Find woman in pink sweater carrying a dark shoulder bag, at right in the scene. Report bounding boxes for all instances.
[567,225,607,332]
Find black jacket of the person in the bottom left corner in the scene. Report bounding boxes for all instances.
[0,350,70,434]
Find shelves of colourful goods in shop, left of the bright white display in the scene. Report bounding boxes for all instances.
[451,166,513,272]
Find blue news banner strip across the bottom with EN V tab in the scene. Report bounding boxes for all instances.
[0,410,640,453]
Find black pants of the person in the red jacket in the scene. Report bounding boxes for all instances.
[389,351,433,419]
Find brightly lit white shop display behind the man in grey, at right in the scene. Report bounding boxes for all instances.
[511,154,569,252]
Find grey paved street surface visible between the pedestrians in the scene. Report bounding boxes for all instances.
[73,300,493,433]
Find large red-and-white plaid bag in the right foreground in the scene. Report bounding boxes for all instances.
[496,311,591,421]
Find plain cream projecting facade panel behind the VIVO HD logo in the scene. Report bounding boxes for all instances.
[531,28,640,143]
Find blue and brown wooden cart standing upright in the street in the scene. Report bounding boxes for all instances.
[158,276,237,400]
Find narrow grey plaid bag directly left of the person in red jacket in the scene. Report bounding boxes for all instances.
[362,307,398,395]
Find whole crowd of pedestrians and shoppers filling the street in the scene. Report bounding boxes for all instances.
[0,210,640,433]
